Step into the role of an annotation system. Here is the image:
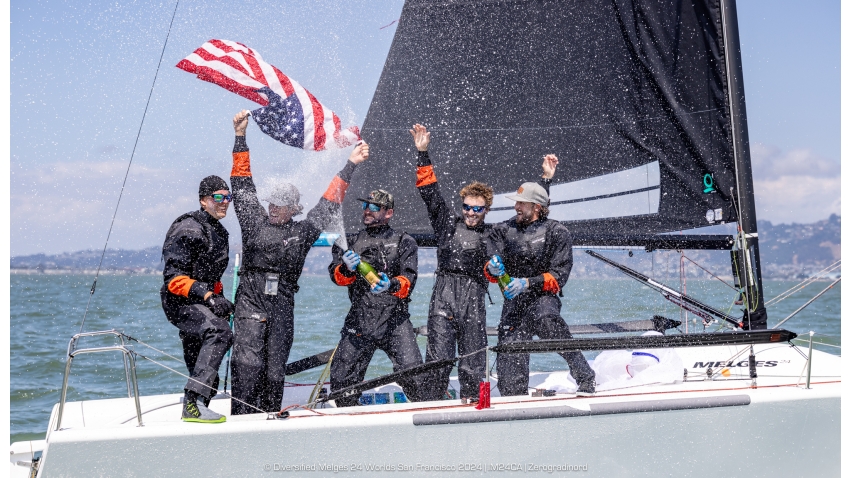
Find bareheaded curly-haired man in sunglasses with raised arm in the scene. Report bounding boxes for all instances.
[410,124,493,401]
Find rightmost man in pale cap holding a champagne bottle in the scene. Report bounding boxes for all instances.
[484,154,596,396]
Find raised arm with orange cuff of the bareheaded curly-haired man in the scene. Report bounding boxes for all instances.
[410,124,453,237]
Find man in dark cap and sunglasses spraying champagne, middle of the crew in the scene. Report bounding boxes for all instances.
[328,189,422,407]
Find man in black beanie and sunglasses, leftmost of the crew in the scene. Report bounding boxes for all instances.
[160,176,233,423]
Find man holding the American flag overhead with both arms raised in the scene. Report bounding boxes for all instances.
[230,111,369,415]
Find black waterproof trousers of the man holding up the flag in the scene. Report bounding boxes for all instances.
[230,273,295,415]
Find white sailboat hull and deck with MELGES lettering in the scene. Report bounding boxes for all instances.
[12,345,841,478]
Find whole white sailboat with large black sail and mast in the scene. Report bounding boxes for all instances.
[11,0,841,477]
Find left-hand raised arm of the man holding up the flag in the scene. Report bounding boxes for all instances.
[230,110,268,244]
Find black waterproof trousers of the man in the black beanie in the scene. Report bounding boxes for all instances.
[160,288,233,403]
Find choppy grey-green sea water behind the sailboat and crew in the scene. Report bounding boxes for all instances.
[9,275,841,442]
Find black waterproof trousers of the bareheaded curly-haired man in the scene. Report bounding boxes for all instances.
[423,273,487,400]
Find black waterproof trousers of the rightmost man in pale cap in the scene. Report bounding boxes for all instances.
[496,293,596,397]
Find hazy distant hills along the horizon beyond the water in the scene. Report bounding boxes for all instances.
[10,214,841,279]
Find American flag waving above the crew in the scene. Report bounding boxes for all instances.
[177,40,360,151]
